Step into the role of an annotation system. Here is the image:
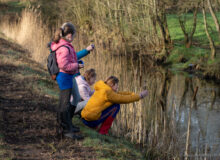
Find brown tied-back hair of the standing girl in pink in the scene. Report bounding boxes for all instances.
[53,22,76,43]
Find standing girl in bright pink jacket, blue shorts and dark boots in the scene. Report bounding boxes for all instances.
[51,22,93,139]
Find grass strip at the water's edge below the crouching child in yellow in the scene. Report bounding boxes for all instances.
[73,118,144,160]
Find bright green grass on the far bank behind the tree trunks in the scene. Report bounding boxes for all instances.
[166,12,220,73]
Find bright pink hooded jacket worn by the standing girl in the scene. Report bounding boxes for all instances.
[51,38,79,74]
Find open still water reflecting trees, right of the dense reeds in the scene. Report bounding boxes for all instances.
[163,75,220,159]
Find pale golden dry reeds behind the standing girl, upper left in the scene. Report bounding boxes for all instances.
[0,9,51,65]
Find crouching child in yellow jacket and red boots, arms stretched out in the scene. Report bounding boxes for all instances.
[81,76,148,134]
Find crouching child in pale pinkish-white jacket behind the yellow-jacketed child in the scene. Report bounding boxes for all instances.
[75,69,96,114]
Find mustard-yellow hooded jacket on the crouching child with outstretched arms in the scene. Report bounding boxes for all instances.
[81,81,140,121]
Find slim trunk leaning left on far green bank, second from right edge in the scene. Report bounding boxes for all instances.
[202,0,216,59]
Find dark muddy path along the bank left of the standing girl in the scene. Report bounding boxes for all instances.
[0,38,95,160]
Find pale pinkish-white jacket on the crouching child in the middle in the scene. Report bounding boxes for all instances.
[75,76,94,100]
